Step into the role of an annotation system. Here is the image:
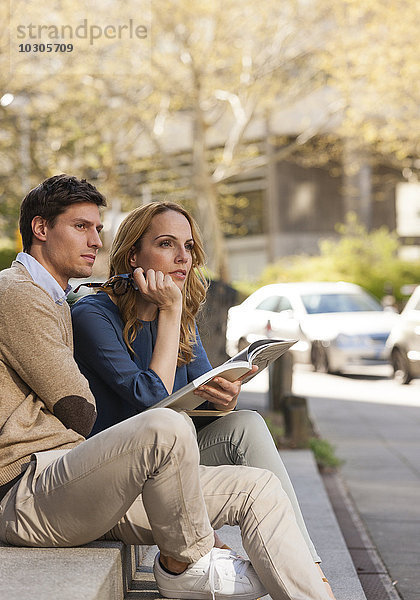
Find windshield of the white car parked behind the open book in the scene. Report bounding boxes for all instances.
[301,294,383,315]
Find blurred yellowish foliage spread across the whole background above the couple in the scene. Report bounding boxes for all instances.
[0,0,420,278]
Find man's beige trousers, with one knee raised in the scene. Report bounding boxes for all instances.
[0,409,328,600]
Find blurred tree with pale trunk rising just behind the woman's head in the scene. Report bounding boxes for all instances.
[124,0,328,277]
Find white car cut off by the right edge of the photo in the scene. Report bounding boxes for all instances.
[386,286,420,384]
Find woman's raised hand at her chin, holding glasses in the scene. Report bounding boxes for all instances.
[133,267,182,310]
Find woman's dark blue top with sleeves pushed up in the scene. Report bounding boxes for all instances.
[71,292,211,435]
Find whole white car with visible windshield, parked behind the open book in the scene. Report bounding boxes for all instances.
[226,282,398,373]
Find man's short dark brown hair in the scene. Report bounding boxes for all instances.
[19,174,106,252]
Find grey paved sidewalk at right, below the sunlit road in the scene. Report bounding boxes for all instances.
[309,397,420,600]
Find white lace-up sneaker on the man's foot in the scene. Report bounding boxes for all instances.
[153,548,267,600]
